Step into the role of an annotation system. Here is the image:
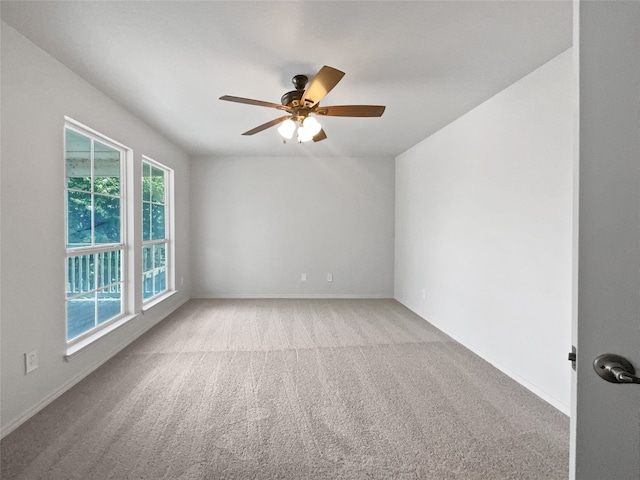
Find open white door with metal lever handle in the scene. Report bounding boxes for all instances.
[572,0,640,480]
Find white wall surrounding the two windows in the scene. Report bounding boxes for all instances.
[0,23,189,435]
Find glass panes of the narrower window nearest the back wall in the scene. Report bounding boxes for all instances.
[142,158,172,302]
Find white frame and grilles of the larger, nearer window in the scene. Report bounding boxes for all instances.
[63,117,131,347]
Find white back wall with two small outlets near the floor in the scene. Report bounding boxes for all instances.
[191,157,394,298]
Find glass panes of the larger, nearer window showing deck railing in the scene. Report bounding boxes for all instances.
[65,124,126,341]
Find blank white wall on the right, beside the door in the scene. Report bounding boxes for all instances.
[395,51,575,413]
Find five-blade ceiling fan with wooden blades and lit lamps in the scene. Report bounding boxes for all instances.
[220,65,385,143]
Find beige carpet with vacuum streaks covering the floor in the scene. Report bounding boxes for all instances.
[1,299,569,480]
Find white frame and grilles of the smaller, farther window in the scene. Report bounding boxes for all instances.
[139,155,175,304]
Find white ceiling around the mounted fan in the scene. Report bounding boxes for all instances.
[1,0,572,157]
